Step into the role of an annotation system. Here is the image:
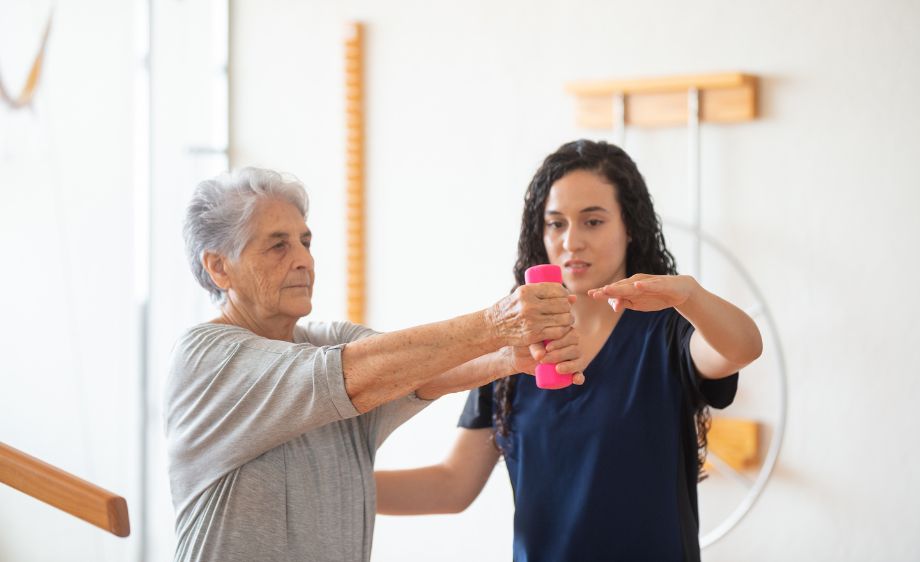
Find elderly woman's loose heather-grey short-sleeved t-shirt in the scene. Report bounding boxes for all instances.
[165,322,429,562]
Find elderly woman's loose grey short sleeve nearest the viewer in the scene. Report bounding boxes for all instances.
[164,323,359,506]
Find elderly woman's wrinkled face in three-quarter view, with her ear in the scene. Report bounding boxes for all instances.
[227,199,314,320]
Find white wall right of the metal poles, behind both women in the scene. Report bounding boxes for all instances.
[231,0,920,561]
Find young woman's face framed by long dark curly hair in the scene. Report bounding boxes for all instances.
[543,170,629,294]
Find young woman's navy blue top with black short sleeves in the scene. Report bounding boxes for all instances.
[459,308,738,562]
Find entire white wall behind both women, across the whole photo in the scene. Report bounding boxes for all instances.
[0,0,920,562]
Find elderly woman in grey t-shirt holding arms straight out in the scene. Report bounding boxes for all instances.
[165,168,583,562]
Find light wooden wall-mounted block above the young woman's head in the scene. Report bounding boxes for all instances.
[566,72,758,129]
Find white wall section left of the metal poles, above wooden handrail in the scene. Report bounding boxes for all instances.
[0,0,140,562]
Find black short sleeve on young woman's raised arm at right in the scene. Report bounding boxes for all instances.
[668,311,738,409]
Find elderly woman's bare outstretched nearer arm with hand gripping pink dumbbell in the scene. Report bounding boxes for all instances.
[342,283,577,413]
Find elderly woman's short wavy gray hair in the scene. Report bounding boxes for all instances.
[182,167,309,304]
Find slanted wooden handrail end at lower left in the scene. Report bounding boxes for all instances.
[0,442,131,537]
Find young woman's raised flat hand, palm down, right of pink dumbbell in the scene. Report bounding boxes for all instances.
[588,273,700,312]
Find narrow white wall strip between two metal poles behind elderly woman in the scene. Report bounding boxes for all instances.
[145,0,228,560]
